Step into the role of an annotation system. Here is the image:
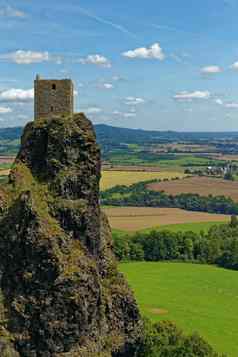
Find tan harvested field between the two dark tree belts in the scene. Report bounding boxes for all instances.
[103,207,230,232]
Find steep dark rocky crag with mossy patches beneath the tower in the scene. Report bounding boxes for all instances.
[0,114,140,357]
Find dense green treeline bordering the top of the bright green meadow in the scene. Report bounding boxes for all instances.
[113,218,238,270]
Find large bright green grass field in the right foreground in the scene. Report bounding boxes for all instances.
[119,262,238,357]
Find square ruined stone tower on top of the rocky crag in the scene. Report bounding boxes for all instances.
[34,75,74,120]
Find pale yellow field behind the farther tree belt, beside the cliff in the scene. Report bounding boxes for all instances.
[100,171,185,190]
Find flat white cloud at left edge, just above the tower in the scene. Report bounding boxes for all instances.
[0,50,50,64]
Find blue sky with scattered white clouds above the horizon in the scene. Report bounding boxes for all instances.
[0,0,238,131]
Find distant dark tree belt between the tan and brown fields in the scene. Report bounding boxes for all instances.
[101,180,238,214]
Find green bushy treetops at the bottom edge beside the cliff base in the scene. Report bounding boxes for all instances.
[131,320,225,357]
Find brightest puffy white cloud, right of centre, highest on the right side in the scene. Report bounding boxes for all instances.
[122,43,165,61]
